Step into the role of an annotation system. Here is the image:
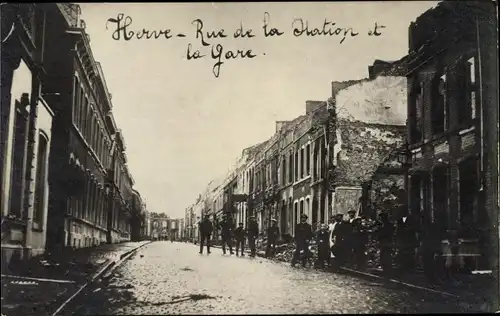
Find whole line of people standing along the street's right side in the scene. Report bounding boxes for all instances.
[198,210,425,278]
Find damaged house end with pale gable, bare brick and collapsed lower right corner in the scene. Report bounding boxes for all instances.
[330,72,407,217]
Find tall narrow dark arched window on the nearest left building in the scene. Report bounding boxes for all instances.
[33,134,48,224]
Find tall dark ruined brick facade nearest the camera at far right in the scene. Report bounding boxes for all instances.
[405,1,498,271]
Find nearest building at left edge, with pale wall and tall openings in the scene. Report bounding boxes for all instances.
[0,3,57,267]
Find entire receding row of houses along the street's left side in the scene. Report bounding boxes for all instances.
[0,3,146,262]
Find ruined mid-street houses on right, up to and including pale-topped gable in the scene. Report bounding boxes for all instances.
[189,71,407,236]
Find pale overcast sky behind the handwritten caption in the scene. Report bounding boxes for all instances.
[81,1,436,217]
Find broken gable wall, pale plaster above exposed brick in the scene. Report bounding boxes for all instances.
[332,76,407,214]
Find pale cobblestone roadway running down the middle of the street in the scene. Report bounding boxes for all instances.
[76,242,484,315]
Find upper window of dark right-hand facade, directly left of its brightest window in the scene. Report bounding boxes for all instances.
[431,74,447,134]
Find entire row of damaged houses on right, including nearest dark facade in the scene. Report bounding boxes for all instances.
[185,1,499,271]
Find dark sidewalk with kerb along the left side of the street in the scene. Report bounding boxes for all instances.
[1,241,149,316]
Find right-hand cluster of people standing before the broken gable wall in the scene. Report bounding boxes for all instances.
[292,210,425,272]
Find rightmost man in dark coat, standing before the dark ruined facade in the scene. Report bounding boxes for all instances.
[396,209,417,271]
